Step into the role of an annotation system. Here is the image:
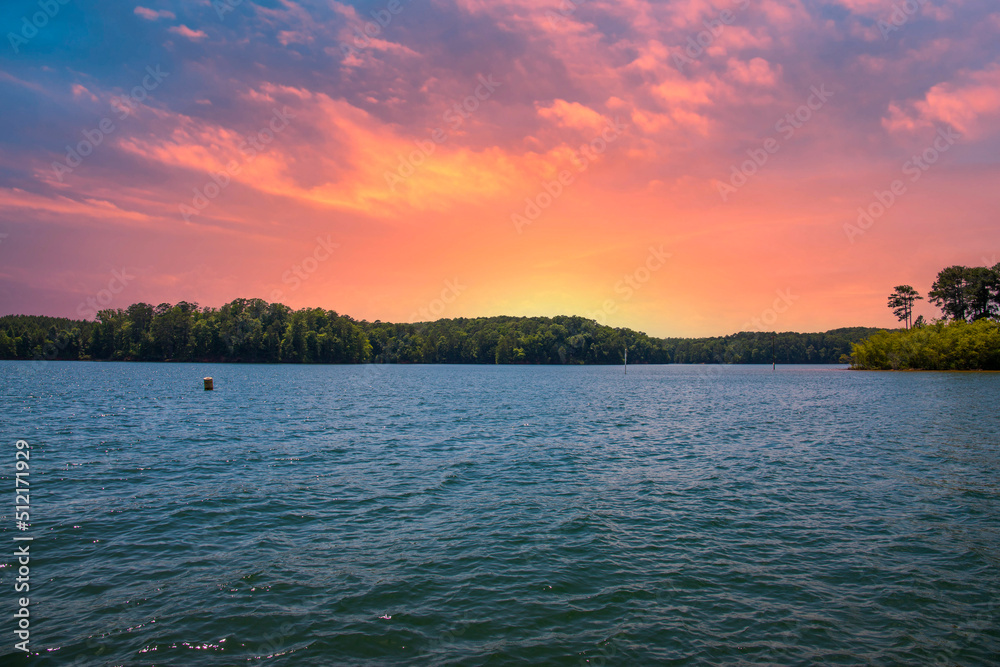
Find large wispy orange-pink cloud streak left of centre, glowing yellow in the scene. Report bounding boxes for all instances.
[108,84,540,217]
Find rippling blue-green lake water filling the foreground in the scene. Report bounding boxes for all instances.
[0,362,1000,665]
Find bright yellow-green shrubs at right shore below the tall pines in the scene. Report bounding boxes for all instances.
[851,319,1000,371]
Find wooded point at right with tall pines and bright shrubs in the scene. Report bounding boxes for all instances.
[851,264,1000,371]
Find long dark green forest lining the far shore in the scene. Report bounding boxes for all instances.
[0,299,877,364]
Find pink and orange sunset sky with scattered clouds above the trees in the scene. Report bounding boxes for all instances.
[0,0,1000,336]
